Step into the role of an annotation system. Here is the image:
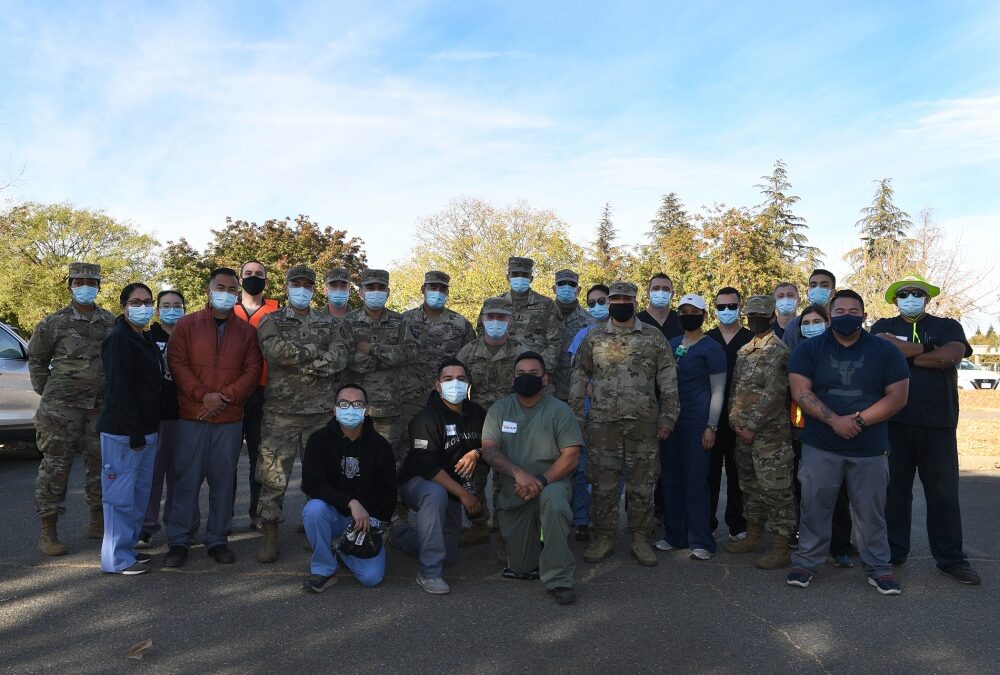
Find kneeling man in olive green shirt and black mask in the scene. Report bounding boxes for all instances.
[482,351,583,605]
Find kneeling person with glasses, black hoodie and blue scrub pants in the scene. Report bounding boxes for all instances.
[302,384,396,593]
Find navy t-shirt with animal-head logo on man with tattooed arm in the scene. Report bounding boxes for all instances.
[788,329,910,457]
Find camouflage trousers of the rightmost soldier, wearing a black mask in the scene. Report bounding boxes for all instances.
[735,433,796,537]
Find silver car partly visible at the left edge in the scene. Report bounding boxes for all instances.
[0,323,40,441]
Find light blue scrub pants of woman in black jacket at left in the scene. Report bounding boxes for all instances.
[101,433,158,573]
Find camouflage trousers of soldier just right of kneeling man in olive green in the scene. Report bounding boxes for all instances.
[584,420,660,537]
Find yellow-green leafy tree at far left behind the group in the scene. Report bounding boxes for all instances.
[0,203,159,333]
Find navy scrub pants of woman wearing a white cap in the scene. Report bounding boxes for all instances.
[660,424,715,553]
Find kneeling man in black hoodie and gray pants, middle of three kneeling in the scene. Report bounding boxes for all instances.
[391,359,486,595]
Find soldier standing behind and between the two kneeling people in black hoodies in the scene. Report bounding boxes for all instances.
[341,269,420,468]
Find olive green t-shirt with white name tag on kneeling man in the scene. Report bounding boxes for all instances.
[483,394,583,510]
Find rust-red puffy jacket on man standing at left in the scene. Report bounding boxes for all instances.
[167,306,263,424]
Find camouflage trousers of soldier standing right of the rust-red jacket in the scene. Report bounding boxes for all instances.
[254,412,330,522]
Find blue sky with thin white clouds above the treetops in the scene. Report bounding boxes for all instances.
[0,1,1000,324]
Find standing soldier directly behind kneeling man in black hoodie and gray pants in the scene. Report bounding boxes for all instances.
[400,270,476,428]
